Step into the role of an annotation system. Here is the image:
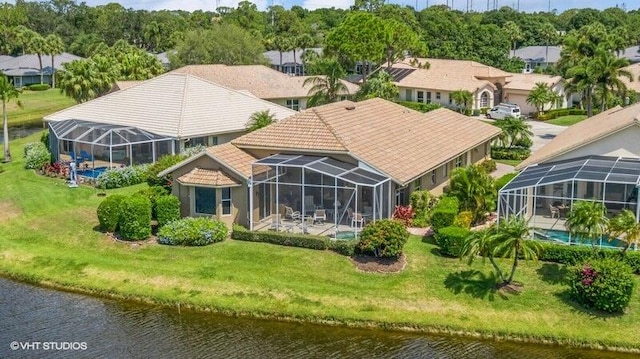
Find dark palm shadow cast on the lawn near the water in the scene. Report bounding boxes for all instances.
[444,270,509,301]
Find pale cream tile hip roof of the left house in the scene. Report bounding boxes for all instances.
[44,73,296,138]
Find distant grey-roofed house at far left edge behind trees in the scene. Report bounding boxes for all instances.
[0,52,82,87]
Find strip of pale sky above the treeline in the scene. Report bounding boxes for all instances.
[0,0,640,12]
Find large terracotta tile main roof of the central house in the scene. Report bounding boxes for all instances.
[232,98,500,184]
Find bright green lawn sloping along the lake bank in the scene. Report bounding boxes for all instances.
[0,134,640,349]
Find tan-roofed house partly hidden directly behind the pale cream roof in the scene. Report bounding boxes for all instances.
[173,65,359,111]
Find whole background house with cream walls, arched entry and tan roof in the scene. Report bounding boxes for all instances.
[382,58,512,109]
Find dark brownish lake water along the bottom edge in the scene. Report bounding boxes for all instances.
[0,278,637,359]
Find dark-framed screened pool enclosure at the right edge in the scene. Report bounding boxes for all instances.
[498,156,640,239]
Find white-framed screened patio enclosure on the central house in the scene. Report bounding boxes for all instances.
[249,154,392,237]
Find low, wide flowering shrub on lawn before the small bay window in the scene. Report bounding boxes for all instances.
[158,217,228,246]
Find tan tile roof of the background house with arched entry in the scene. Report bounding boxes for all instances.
[383,58,511,93]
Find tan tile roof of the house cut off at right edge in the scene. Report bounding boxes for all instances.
[516,103,640,169]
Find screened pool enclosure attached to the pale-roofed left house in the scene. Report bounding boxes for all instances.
[48,120,175,168]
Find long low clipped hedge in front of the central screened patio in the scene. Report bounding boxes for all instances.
[231,225,357,256]
